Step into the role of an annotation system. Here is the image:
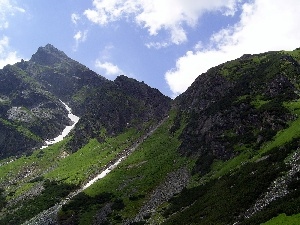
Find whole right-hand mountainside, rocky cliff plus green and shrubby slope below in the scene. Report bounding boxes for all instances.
[162,49,300,224]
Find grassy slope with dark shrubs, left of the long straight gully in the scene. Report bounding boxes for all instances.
[0,129,143,224]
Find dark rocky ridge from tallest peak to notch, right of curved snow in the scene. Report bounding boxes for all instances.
[19,44,171,152]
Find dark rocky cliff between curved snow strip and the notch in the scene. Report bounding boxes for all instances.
[69,75,171,151]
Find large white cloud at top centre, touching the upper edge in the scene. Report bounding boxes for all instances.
[84,0,240,47]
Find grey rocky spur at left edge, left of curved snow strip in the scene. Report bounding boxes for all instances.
[0,63,70,158]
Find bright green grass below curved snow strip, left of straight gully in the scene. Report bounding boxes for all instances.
[0,129,141,202]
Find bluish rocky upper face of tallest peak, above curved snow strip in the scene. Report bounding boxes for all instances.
[16,44,111,116]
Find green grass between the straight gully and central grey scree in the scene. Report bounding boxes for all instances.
[61,111,193,224]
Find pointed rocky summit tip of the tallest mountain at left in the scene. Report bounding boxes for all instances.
[30,44,69,66]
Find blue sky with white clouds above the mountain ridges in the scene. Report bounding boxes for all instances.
[0,0,300,98]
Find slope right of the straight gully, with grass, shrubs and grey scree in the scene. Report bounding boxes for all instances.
[58,112,191,224]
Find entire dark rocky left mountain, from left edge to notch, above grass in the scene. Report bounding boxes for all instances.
[0,44,171,158]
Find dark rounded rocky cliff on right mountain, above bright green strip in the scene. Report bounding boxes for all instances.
[175,52,300,173]
